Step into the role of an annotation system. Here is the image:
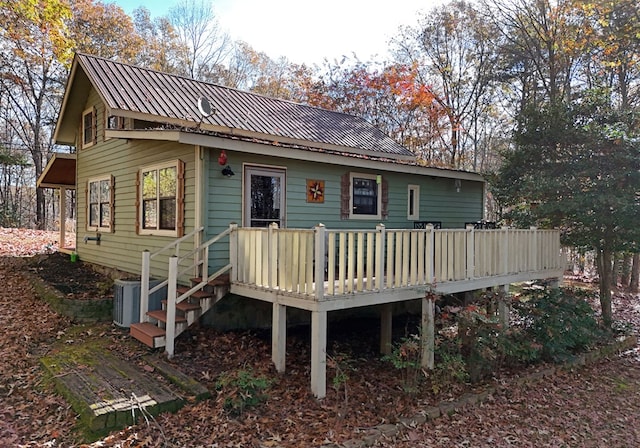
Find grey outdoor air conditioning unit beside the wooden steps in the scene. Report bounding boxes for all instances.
[113,279,167,328]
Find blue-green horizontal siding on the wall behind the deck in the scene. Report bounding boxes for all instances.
[205,149,483,267]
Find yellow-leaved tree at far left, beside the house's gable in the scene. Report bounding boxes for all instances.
[0,0,71,228]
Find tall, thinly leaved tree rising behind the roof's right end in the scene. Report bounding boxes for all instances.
[393,0,502,170]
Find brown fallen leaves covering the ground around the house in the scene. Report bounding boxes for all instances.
[0,229,640,448]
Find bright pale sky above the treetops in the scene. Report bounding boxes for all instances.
[110,0,446,65]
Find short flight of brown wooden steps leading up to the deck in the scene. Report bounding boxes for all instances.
[129,274,230,348]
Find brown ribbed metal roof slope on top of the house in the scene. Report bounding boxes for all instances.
[76,54,413,158]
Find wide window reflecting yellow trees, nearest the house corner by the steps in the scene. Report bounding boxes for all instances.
[138,161,184,236]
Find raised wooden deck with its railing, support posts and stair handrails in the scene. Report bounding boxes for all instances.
[141,224,565,398]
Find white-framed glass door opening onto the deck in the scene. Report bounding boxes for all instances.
[243,166,286,228]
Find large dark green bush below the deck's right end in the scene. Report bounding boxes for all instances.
[513,288,605,362]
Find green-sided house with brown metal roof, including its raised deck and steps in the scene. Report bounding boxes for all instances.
[39,54,562,397]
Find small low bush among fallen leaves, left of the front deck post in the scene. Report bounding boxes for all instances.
[216,369,271,415]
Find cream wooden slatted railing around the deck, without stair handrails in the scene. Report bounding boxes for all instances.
[231,225,563,300]
